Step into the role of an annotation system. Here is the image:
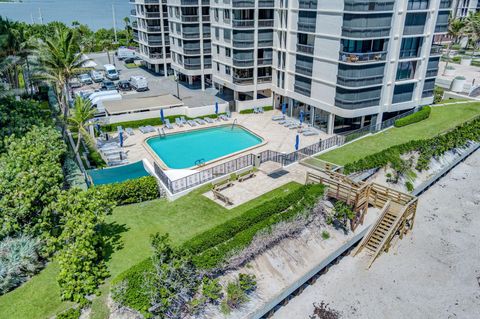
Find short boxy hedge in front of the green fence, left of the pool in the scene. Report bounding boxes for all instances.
[95,176,160,205]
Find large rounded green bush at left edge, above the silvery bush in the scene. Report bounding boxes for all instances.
[0,126,66,238]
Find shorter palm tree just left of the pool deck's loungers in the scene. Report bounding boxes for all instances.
[68,97,95,153]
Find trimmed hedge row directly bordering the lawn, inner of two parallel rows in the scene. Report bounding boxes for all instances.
[183,186,316,255]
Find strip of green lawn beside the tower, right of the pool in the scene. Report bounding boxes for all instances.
[318,102,480,165]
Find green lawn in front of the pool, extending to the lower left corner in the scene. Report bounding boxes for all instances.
[0,183,300,319]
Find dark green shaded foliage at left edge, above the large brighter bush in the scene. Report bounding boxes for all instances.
[0,97,53,153]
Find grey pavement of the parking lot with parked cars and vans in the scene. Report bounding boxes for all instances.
[74,52,229,107]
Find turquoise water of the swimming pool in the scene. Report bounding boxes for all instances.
[147,125,262,169]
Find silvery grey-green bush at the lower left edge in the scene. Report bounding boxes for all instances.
[0,235,41,295]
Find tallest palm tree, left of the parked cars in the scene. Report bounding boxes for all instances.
[37,28,90,131]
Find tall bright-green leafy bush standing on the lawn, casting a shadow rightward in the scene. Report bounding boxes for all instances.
[50,188,113,303]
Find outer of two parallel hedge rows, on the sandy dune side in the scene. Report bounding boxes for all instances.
[193,185,324,269]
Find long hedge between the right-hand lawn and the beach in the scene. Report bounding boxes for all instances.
[344,117,480,174]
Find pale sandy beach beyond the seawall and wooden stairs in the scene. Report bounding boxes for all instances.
[273,151,480,319]
